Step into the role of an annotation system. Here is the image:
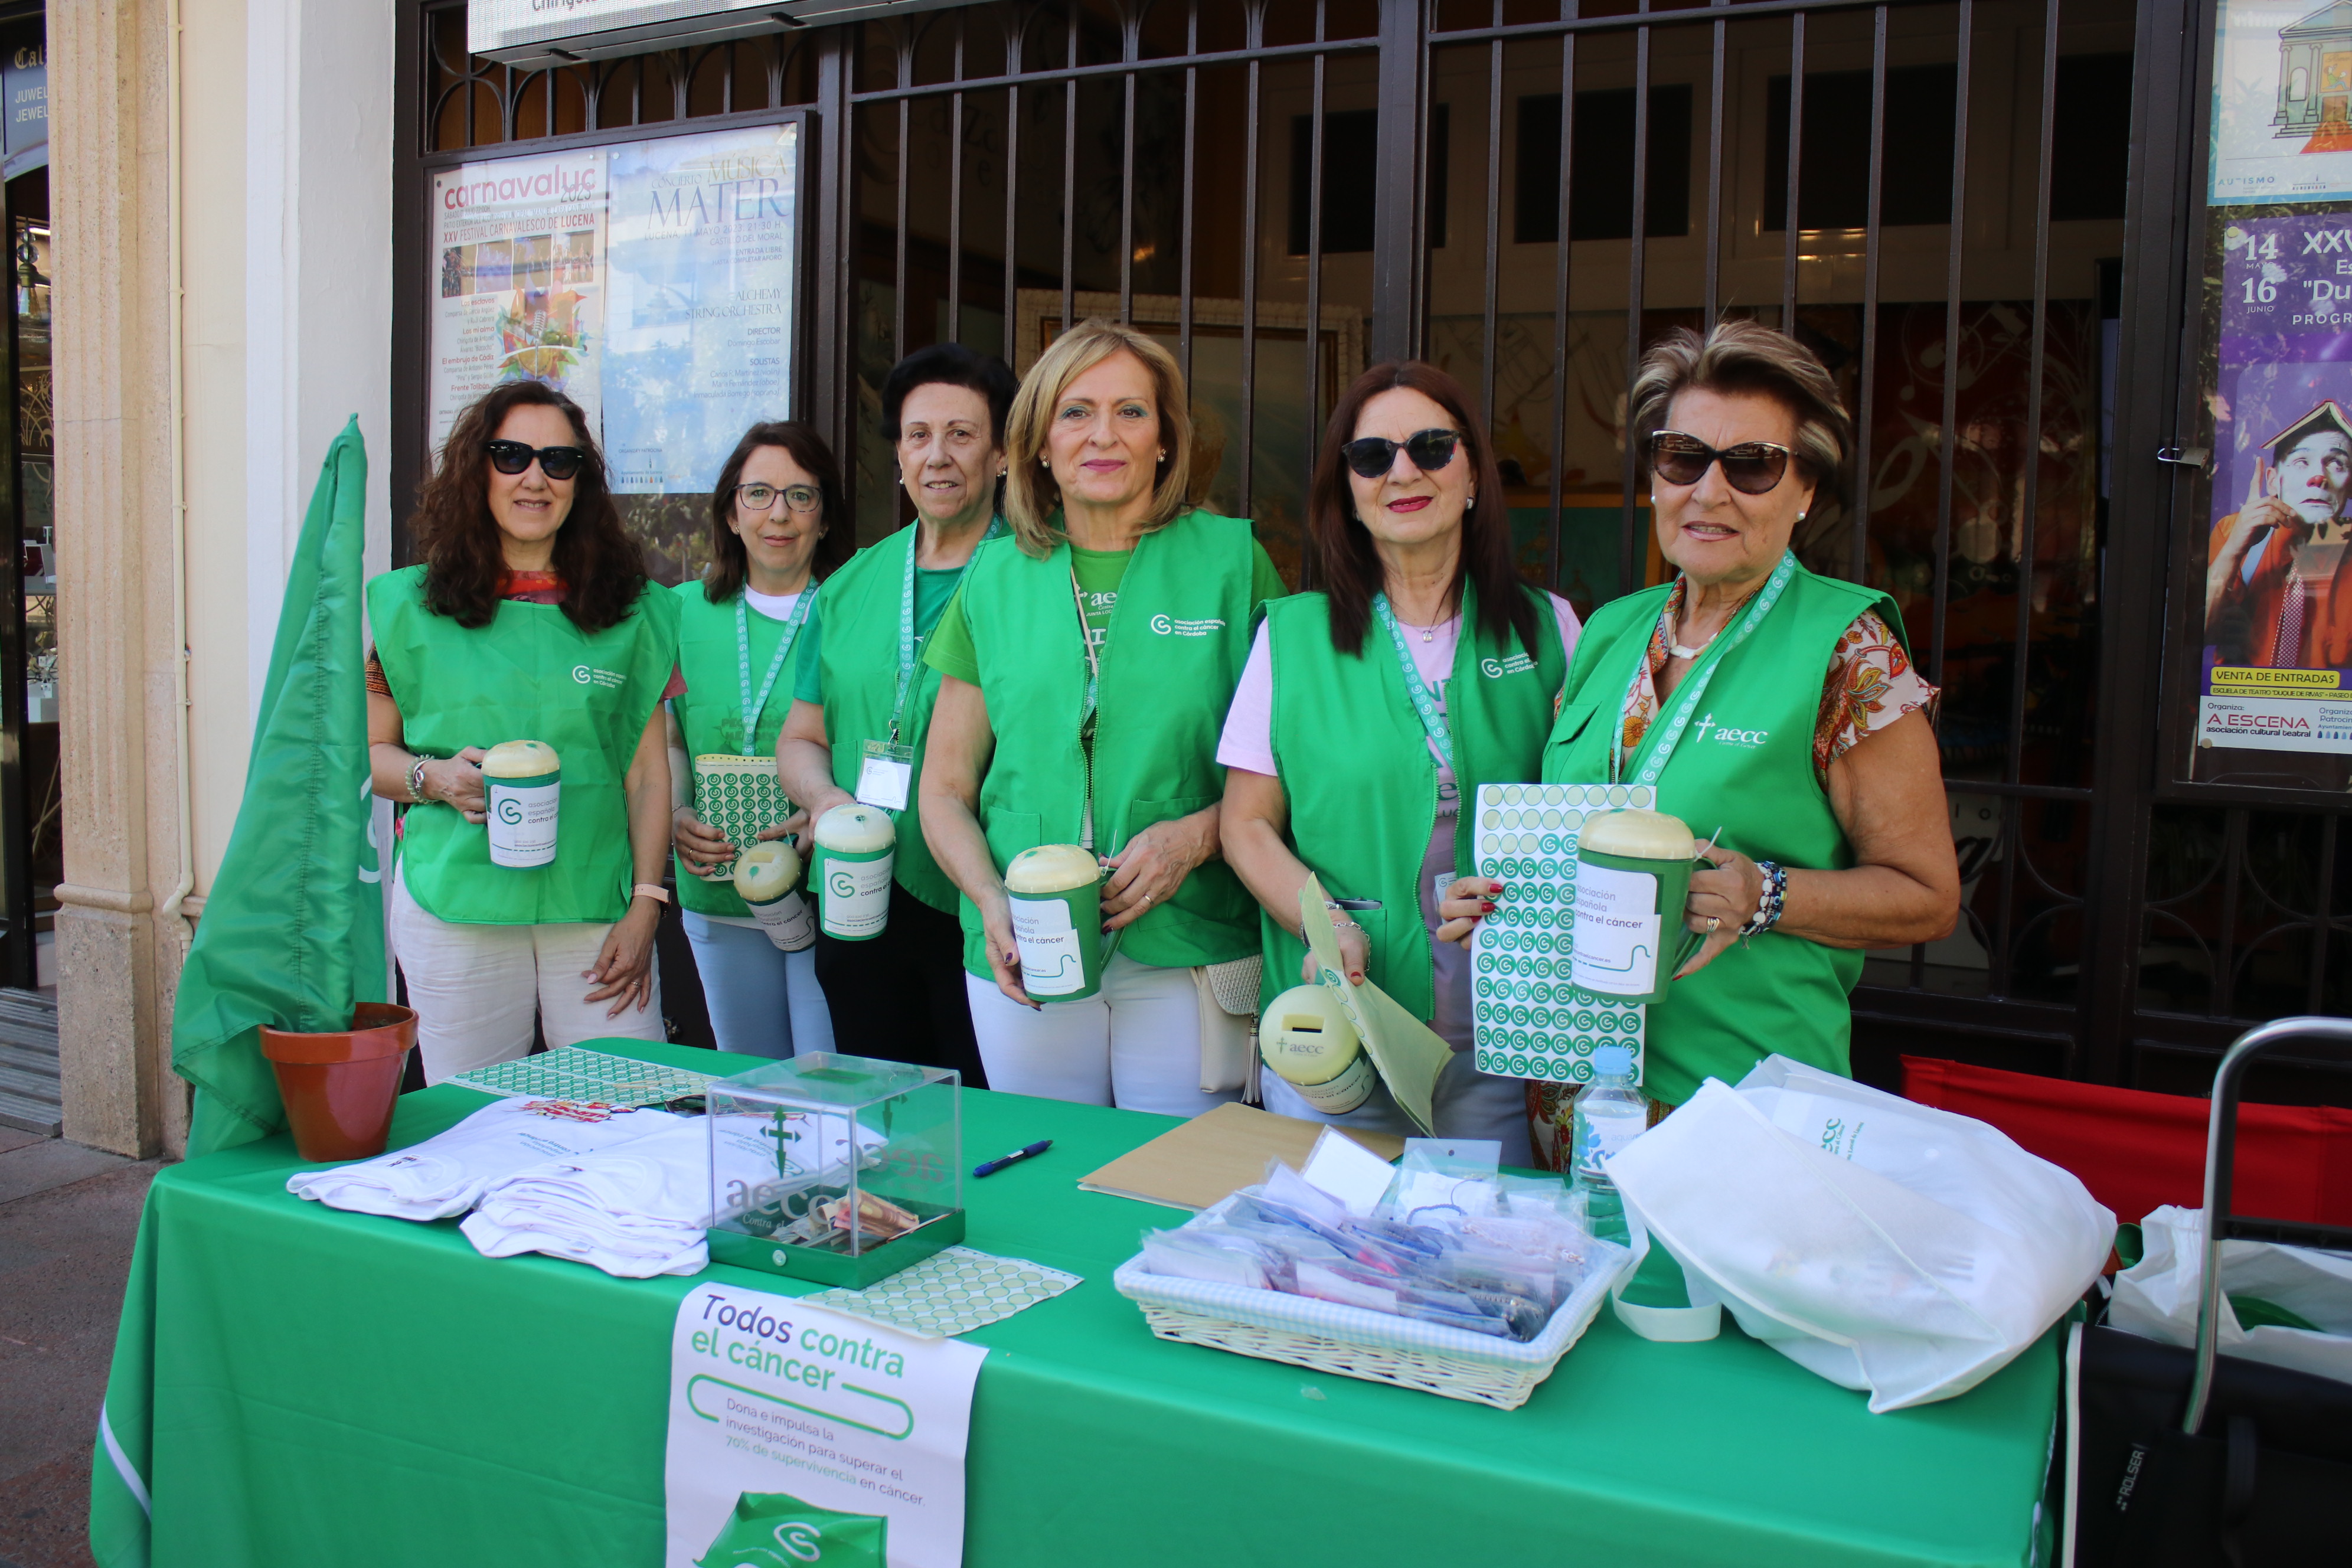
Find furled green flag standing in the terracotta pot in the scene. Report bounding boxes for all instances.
[172,419,386,1159]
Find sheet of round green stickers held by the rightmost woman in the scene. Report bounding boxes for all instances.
[1470,783,1658,1084]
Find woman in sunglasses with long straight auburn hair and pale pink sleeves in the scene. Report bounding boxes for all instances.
[1216,360,1576,1164]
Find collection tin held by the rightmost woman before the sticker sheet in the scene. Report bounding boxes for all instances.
[1569,809,1705,1001]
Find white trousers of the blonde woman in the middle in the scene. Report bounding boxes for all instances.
[964,952,1249,1116]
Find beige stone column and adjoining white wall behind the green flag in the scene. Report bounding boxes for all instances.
[50,0,393,1154]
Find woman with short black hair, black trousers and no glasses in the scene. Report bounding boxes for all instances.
[776,343,1021,1089]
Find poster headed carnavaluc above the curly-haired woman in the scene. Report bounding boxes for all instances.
[428,148,605,447]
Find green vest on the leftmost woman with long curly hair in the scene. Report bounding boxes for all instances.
[367,567,677,926]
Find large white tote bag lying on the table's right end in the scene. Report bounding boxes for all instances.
[1609,1056,2115,1413]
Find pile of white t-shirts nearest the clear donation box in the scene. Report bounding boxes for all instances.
[463,1114,882,1279]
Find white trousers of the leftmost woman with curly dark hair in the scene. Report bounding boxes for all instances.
[393,874,668,1084]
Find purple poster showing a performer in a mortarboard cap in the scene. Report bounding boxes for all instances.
[2197,214,2352,754]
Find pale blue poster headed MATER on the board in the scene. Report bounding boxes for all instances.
[605,125,800,496]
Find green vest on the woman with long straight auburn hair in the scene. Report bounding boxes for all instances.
[1258,581,1569,1023]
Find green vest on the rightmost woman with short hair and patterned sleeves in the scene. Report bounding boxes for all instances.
[1543,567,1903,1105]
